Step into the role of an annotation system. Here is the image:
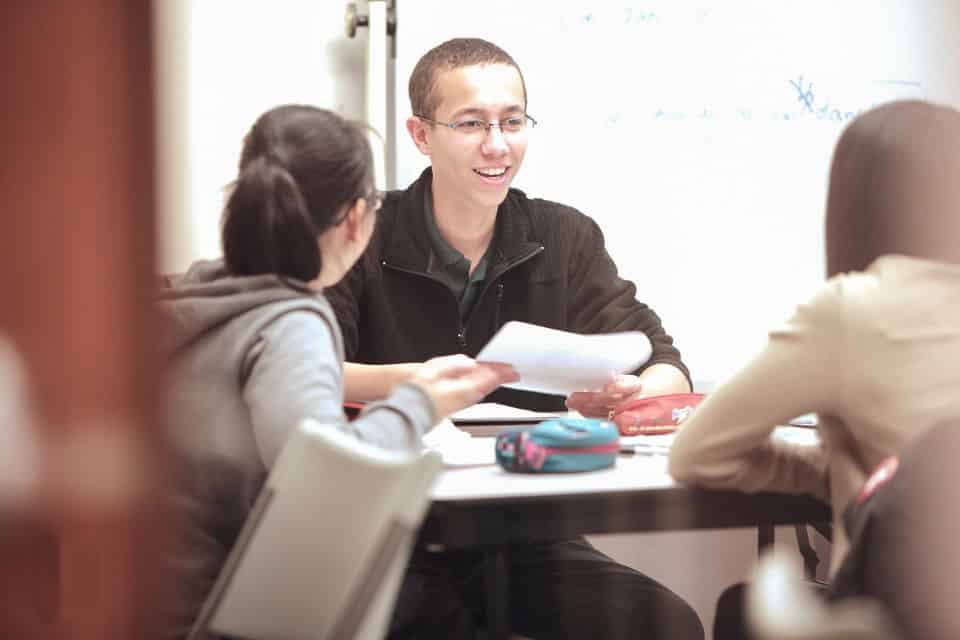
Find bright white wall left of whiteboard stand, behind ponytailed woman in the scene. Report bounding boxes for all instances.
[154,0,367,272]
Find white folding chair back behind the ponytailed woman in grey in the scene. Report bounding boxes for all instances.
[189,420,442,640]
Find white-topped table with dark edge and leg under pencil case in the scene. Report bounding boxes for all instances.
[418,439,830,638]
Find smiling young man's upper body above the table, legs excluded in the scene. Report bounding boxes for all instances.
[328,39,690,417]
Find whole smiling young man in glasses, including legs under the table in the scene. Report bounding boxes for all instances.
[326,39,703,639]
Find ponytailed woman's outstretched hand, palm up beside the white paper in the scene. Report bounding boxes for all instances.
[410,354,519,420]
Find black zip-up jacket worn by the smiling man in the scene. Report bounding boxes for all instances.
[324,168,689,411]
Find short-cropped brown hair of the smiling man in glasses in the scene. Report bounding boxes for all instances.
[408,38,527,118]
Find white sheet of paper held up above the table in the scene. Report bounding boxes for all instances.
[476,321,651,396]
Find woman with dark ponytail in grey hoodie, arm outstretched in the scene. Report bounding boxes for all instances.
[160,105,516,629]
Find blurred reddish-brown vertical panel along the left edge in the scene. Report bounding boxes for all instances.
[0,0,172,640]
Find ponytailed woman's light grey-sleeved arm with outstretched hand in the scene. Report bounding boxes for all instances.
[241,311,517,467]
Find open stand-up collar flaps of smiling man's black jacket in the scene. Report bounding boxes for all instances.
[381,167,543,273]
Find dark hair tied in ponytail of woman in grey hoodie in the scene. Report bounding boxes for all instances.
[221,105,373,282]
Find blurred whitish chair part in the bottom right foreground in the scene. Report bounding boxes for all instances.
[746,545,900,640]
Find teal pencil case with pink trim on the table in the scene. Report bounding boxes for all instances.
[496,418,620,473]
